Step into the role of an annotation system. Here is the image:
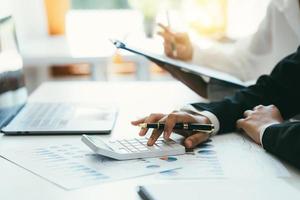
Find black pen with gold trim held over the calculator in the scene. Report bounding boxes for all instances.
[139,123,214,133]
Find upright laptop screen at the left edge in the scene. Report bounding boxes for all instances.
[0,16,27,128]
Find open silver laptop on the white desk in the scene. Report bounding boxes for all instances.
[0,16,117,135]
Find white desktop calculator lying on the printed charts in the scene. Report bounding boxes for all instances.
[81,135,185,160]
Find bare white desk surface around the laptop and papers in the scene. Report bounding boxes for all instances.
[0,82,300,200]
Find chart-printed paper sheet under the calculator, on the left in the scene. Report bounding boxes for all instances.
[0,142,179,190]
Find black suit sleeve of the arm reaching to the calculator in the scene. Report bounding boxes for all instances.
[192,48,300,133]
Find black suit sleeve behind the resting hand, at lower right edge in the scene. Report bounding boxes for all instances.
[262,122,300,168]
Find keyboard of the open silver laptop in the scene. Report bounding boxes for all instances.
[19,103,75,128]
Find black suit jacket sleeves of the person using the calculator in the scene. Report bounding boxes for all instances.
[193,47,300,168]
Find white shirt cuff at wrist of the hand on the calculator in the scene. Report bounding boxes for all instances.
[180,105,220,135]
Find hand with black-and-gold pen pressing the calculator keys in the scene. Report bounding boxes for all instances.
[131,112,213,148]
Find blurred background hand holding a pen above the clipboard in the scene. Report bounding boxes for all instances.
[158,24,193,61]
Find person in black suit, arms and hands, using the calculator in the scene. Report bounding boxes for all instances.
[132,47,300,168]
